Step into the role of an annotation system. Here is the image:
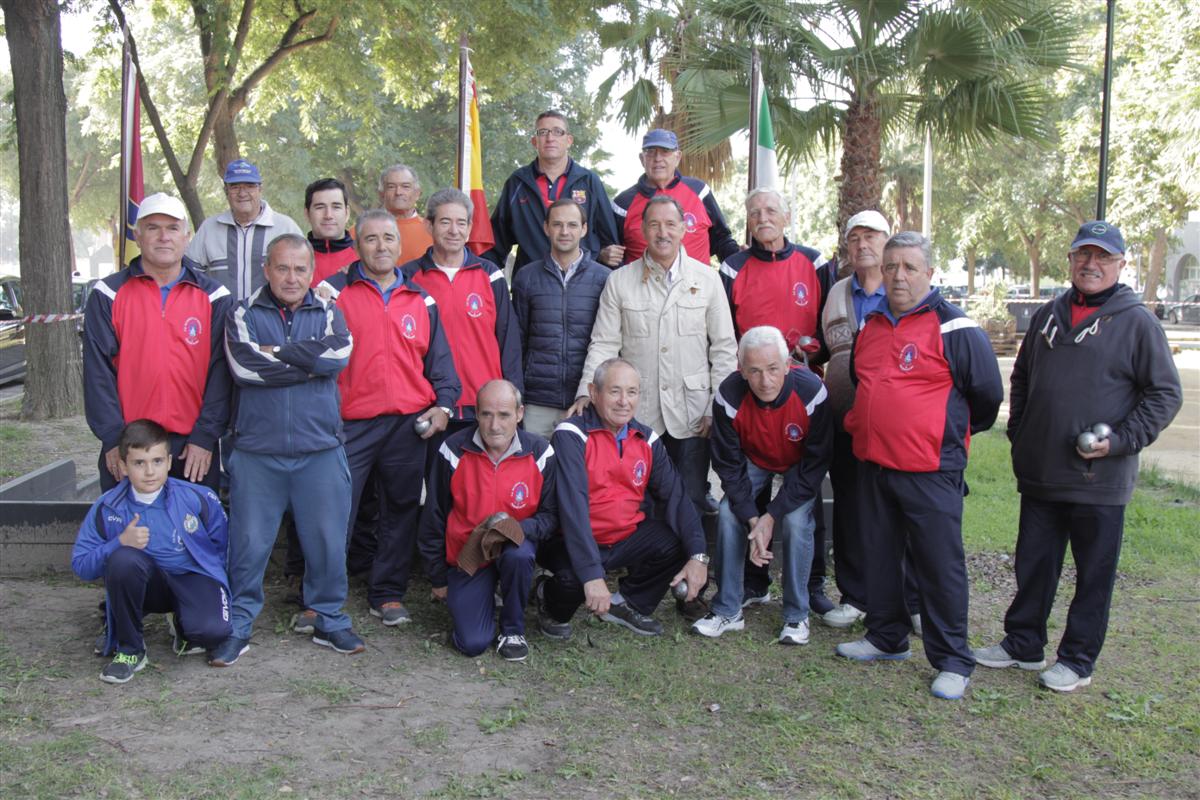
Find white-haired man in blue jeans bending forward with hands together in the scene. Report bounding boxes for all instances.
[691,325,833,644]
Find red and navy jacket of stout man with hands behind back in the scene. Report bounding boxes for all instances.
[845,289,1004,473]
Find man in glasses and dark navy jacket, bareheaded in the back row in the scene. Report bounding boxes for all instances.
[484,110,619,276]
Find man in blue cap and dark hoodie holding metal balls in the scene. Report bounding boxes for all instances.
[974,221,1183,692]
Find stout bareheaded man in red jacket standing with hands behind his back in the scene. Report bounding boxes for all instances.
[838,231,1003,699]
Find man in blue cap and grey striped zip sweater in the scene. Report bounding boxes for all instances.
[187,158,304,302]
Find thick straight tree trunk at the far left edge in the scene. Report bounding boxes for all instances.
[0,0,83,420]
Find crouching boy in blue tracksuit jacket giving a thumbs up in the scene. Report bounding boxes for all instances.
[71,420,230,684]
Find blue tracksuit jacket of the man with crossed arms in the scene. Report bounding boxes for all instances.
[226,283,354,456]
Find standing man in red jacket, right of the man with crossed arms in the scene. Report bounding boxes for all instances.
[325,209,461,626]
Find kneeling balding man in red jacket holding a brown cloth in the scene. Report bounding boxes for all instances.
[419,380,558,661]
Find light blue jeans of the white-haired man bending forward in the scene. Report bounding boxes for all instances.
[713,461,814,625]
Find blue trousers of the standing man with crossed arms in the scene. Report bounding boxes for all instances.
[229,445,350,639]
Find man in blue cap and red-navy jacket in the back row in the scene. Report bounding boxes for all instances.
[596,128,739,266]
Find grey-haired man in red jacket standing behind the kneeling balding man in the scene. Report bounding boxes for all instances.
[402,188,524,432]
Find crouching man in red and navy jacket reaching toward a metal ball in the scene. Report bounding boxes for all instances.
[538,359,708,638]
